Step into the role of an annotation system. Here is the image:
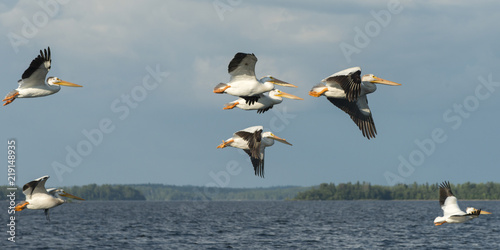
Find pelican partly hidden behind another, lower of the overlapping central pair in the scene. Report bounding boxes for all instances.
[223,89,304,113]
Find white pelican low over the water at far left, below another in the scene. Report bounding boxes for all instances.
[15,175,83,221]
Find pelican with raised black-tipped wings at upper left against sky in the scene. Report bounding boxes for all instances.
[2,47,82,106]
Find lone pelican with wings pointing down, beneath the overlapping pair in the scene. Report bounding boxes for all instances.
[217,126,292,177]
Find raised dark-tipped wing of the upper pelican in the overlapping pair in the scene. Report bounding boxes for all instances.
[227,52,257,81]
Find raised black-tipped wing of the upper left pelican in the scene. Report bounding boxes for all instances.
[19,47,52,88]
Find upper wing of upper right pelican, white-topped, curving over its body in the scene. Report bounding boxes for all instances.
[323,67,361,101]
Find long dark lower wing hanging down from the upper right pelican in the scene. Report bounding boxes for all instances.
[327,96,377,139]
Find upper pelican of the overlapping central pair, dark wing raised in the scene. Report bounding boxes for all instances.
[214,52,297,105]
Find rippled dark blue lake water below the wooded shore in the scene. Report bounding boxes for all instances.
[0,201,500,249]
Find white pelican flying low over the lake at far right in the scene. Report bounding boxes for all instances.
[434,181,491,226]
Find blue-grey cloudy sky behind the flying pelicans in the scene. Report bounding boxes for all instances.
[0,0,500,187]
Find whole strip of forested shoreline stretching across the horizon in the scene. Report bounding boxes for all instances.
[0,182,500,201]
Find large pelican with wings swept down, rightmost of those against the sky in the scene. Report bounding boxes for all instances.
[309,67,401,139]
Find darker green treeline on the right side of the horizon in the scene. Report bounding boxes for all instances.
[294,182,500,200]
